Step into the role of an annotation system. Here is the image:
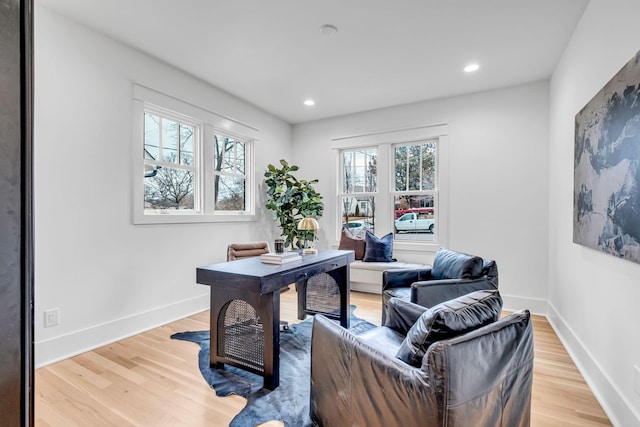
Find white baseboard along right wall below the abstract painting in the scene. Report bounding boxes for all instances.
[547,303,640,426]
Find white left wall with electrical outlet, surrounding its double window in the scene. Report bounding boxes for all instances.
[35,8,291,366]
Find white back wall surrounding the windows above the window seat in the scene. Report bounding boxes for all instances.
[293,82,549,313]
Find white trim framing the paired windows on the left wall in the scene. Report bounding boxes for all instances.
[130,83,260,224]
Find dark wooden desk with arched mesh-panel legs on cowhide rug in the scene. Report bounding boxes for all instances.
[196,250,354,390]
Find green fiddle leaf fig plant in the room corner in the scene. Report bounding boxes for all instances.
[264,159,324,249]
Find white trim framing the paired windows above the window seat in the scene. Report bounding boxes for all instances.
[331,123,449,252]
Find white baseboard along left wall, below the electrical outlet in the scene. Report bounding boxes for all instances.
[34,293,209,369]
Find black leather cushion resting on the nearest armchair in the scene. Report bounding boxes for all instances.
[396,289,502,367]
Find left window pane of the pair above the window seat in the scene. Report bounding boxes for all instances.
[338,148,378,232]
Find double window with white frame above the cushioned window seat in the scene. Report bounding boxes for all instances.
[332,124,448,250]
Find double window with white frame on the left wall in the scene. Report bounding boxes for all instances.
[133,85,257,224]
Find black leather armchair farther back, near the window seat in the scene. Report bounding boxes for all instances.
[382,248,498,322]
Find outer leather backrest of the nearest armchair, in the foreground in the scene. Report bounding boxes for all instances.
[422,310,533,427]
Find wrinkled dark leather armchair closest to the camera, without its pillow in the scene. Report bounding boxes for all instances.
[310,291,533,427]
